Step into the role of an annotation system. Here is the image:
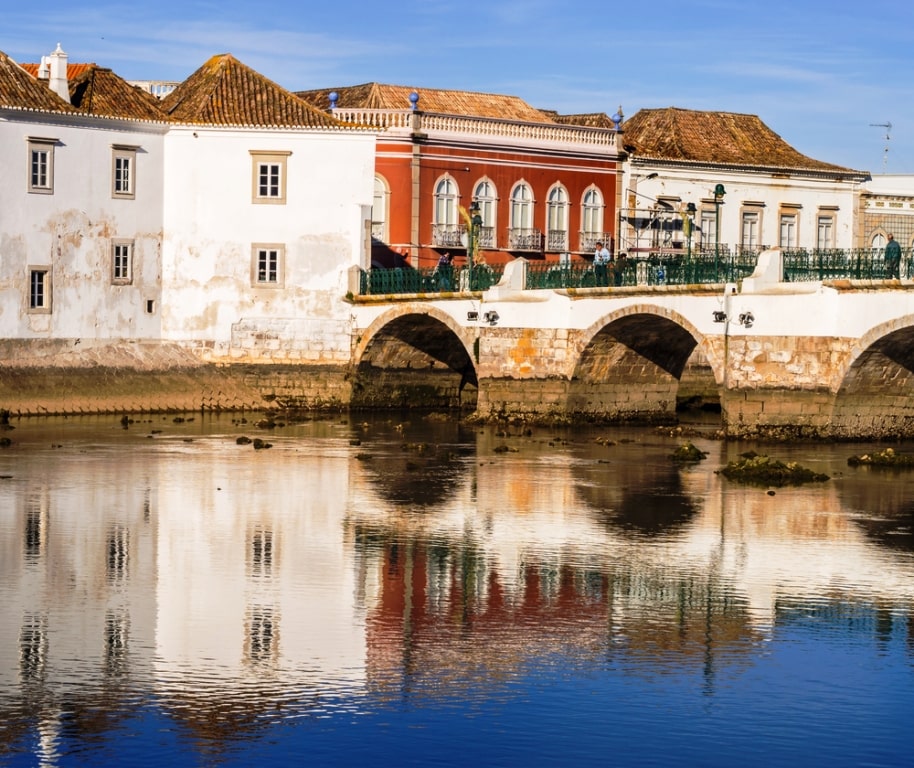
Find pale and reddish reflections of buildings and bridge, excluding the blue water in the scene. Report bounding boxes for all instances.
[0,420,914,763]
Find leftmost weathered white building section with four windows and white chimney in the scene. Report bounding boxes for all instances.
[0,46,168,340]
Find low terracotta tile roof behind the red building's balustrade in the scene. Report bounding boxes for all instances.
[296,83,553,123]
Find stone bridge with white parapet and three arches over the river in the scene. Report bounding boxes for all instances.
[352,251,914,438]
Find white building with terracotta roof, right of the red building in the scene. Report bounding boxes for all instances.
[619,107,869,254]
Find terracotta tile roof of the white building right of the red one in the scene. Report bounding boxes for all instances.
[622,107,860,173]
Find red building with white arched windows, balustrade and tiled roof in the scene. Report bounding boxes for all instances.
[298,83,622,267]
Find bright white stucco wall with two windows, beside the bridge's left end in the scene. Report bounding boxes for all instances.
[162,126,375,359]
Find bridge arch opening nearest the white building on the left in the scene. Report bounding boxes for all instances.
[350,313,479,411]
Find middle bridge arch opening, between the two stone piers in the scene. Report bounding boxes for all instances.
[568,313,700,422]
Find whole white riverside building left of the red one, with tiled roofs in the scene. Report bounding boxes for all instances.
[0,46,375,362]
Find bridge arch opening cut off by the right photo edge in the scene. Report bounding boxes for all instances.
[828,327,914,439]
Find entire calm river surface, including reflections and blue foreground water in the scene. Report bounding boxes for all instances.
[0,414,914,768]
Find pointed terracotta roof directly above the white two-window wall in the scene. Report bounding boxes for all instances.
[161,53,343,128]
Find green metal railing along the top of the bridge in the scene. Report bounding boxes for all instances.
[360,248,914,295]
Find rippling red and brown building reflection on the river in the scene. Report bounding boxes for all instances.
[356,529,758,694]
